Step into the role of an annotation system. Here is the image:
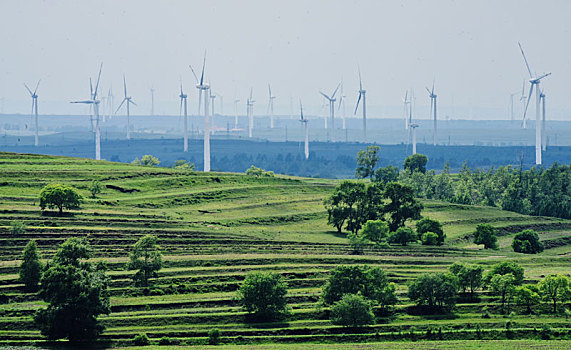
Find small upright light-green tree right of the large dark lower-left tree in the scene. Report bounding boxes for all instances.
[127,235,163,287]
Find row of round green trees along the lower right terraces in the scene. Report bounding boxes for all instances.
[238,262,571,327]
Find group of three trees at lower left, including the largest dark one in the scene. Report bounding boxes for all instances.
[19,235,162,343]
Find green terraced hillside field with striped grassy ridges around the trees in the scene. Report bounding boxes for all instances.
[0,153,571,349]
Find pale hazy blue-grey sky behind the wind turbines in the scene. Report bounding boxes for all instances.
[0,0,571,119]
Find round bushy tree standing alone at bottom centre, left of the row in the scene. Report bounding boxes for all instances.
[238,272,287,320]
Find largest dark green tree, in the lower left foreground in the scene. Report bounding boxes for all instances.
[34,238,110,343]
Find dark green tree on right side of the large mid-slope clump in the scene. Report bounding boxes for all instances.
[382,182,423,232]
